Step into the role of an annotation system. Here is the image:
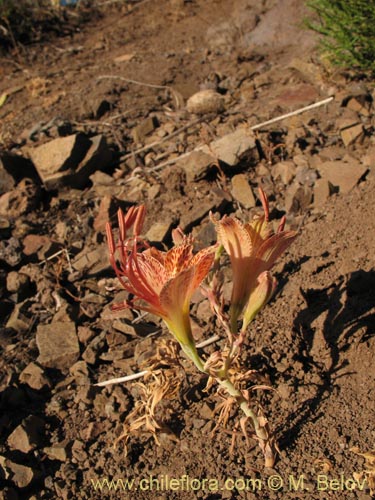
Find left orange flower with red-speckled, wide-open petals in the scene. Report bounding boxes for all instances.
[107,205,216,366]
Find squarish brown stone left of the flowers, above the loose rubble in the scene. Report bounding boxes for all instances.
[36,322,79,370]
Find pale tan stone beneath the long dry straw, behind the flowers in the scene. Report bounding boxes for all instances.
[198,128,255,167]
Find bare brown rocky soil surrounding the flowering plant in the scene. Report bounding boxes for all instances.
[0,0,375,500]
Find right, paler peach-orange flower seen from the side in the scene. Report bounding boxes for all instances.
[213,188,297,332]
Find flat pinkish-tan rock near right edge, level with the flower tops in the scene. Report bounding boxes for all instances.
[318,158,367,193]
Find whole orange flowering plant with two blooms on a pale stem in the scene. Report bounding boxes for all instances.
[107,189,296,466]
